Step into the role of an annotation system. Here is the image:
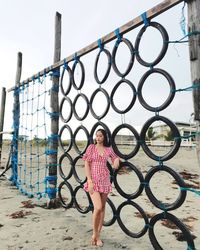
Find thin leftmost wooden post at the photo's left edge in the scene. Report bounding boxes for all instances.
[0,88,6,167]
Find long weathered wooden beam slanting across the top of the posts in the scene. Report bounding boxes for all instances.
[8,0,184,92]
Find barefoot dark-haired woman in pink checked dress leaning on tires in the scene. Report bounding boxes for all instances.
[83,129,120,246]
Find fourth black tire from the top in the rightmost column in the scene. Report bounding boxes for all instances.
[144,165,187,211]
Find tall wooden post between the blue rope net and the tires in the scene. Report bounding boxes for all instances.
[47,12,61,207]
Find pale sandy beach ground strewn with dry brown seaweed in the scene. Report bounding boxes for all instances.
[0,148,200,250]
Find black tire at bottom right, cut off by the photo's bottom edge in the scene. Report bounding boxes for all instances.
[149,213,196,250]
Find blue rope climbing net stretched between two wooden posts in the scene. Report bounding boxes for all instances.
[11,73,51,198]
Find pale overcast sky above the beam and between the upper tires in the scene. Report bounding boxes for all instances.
[0,0,193,136]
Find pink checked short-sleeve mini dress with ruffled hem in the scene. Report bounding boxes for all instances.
[83,144,118,193]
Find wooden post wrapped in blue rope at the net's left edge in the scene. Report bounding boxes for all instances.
[11,52,22,185]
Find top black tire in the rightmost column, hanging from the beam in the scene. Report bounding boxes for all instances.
[135,22,169,67]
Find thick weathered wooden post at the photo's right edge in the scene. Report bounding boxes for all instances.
[188,0,200,166]
